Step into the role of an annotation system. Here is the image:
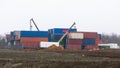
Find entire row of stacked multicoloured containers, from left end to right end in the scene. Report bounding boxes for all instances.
[6,28,103,50]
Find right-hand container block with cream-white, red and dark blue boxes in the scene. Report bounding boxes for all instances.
[67,32,102,50]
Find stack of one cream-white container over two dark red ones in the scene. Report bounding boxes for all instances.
[67,32,84,50]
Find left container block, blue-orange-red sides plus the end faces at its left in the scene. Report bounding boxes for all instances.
[10,31,48,49]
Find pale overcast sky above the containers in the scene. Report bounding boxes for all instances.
[0,0,120,34]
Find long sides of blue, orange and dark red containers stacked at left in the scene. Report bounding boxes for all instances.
[20,31,48,49]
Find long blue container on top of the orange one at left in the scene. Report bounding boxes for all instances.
[20,31,48,38]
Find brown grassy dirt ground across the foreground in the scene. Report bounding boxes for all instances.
[0,49,120,68]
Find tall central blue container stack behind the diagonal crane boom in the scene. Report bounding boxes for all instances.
[48,28,77,48]
